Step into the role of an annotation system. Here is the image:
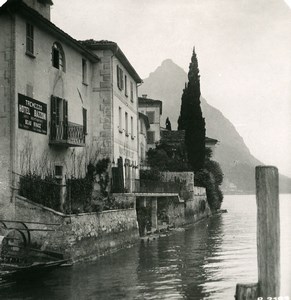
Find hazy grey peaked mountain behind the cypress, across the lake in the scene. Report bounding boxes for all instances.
[139,59,291,193]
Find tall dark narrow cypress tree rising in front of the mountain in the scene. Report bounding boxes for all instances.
[178,48,205,171]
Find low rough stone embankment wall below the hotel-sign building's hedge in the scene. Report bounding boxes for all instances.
[16,197,139,261]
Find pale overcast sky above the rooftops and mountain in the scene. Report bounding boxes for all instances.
[0,0,291,177]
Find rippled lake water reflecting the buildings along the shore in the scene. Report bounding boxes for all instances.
[0,195,291,300]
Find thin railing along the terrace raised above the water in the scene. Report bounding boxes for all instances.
[133,179,182,194]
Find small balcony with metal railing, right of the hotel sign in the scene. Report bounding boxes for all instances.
[49,122,85,147]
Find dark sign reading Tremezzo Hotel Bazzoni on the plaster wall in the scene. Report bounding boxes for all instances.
[18,94,47,134]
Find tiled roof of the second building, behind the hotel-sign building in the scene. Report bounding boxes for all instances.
[79,39,143,83]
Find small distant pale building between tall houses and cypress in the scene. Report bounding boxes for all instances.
[138,95,163,150]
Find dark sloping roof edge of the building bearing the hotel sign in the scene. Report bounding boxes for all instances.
[0,0,100,62]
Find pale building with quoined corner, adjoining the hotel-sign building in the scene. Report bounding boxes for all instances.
[81,40,142,191]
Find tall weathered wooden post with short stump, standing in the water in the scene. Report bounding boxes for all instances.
[235,166,280,300]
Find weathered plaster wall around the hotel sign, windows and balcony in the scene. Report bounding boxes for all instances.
[13,16,99,176]
